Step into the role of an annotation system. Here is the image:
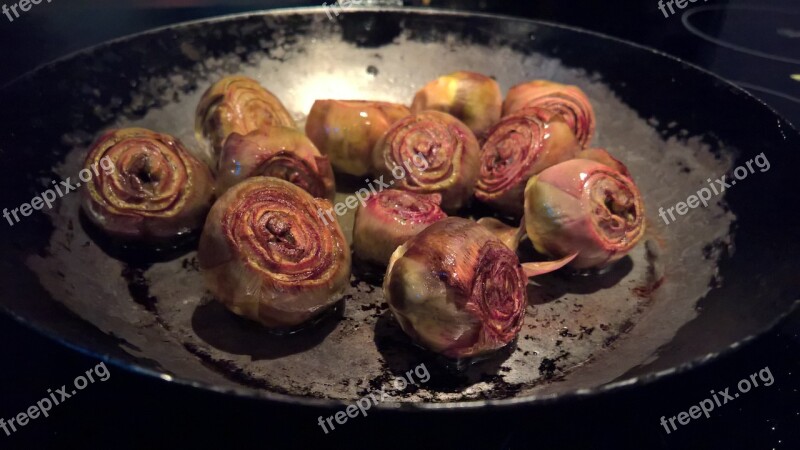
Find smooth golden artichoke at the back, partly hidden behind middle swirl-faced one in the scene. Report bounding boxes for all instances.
[411,72,503,137]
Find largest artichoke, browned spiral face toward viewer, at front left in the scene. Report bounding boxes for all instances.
[198,177,351,328]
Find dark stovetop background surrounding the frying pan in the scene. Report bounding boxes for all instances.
[0,0,800,449]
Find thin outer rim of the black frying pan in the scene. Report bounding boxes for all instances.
[0,7,800,412]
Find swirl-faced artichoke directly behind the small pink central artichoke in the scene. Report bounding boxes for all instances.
[373,111,480,211]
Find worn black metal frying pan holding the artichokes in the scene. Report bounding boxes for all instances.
[0,8,800,410]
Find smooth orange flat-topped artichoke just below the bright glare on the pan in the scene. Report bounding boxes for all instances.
[306,100,411,177]
